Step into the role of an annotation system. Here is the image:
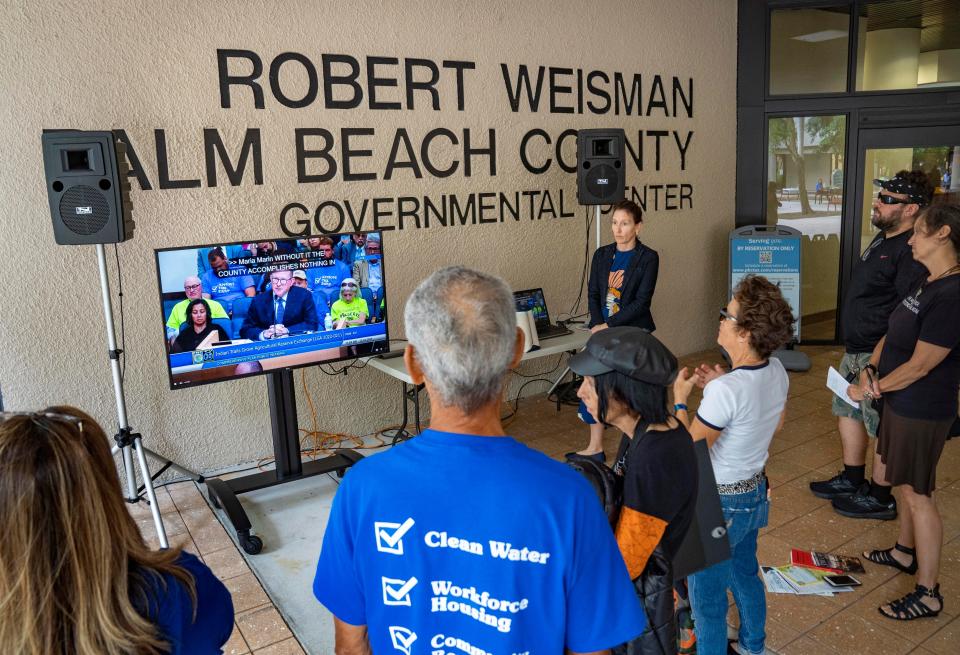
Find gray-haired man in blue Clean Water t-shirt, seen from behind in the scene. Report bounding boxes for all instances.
[313,267,645,655]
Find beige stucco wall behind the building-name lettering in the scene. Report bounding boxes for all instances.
[0,0,736,470]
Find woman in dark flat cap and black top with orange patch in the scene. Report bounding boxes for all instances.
[570,327,697,654]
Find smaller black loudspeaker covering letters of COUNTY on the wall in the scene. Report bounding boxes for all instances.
[577,130,626,205]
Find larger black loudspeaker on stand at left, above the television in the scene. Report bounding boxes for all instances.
[41,130,133,245]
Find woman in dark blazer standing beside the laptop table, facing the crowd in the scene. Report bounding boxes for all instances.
[567,200,660,462]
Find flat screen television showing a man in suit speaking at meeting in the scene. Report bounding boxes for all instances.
[154,232,390,389]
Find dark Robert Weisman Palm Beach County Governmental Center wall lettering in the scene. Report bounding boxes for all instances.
[117,49,694,237]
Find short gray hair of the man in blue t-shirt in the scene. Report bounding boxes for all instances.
[404,266,517,413]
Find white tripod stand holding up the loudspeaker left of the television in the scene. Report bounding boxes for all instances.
[96,243,203,548]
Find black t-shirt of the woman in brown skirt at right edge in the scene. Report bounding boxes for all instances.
[878,275,960,420]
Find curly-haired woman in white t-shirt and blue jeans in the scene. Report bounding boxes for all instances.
[673,275,794,654]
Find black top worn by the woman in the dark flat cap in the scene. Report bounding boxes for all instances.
[614,424,699,559]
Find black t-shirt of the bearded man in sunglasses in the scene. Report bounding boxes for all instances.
[842,230,927,353]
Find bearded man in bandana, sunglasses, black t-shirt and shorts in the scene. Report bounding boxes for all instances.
[810,170,934,520]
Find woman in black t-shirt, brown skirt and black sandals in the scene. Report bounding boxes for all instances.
[848,204,960,620]
